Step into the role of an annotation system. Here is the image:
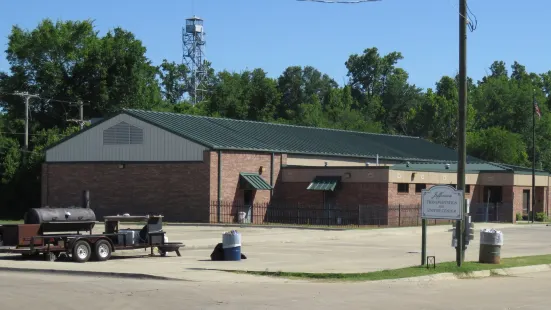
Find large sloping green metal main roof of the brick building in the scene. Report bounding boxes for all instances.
[114,109,480,161]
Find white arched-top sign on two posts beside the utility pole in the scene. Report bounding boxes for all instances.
[421,185,464,266]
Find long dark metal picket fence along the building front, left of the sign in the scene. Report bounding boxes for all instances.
[210,201,460,227]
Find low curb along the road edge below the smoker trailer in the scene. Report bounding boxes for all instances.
[0,267,189,281]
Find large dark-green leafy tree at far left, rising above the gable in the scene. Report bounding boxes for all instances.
[2,19,161,129]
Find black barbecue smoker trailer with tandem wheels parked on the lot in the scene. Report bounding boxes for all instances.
[0,208,183,263]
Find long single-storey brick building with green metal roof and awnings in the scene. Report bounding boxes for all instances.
[41,110,549,225]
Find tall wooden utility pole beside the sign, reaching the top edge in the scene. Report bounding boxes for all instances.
[456,0,467,267]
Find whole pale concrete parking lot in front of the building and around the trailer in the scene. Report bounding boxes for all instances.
[0,224,551,282]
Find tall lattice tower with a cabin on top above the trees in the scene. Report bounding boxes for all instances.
[182,15,207,105]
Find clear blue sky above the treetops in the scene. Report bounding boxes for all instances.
[0,0,551,88]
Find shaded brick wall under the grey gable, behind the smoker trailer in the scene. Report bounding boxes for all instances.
[42,153,210,222]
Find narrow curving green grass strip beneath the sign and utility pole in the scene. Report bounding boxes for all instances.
[231,254,551,281]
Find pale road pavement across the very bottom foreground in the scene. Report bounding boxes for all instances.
[0,272,551,310]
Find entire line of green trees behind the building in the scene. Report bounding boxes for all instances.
[0,19,551,216]
